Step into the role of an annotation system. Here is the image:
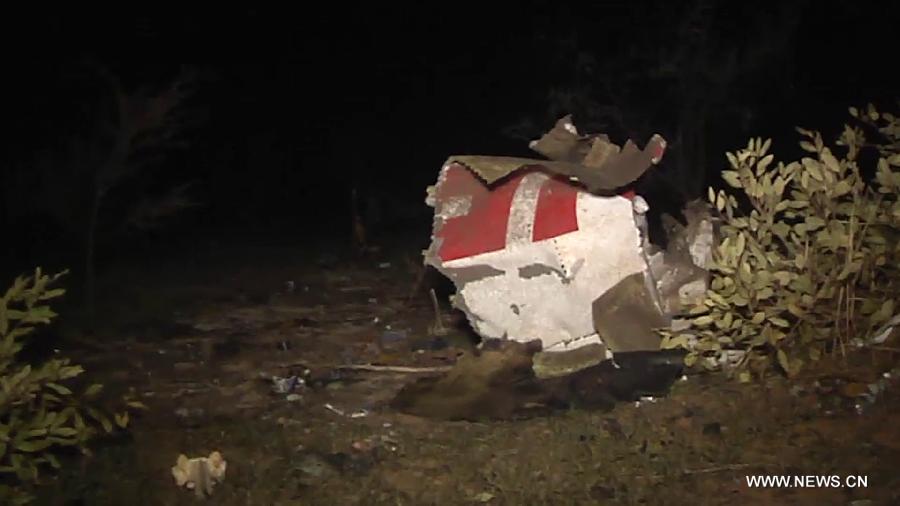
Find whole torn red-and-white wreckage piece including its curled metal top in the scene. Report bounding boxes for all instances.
[425,117,667,356]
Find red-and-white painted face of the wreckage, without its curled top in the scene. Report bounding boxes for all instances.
[426,164,648,350]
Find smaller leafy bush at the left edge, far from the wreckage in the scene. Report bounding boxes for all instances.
[0,269,143,504]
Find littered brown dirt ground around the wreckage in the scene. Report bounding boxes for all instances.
[31,234,900,506]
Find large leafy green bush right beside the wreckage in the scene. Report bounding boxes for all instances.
[664,105,900,381]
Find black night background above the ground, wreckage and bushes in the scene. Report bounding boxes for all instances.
[0,0,898,304]
